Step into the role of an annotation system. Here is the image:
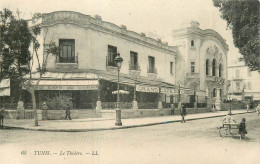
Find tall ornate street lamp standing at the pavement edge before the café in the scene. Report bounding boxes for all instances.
[114,53,123,126]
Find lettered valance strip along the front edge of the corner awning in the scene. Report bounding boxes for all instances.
[29,85,98,90]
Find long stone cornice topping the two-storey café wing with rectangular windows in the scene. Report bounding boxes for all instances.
[42,11,176,55]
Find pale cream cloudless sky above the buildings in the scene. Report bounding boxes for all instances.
[0,0,240,65]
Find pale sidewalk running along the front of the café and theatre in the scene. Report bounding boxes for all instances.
[1,110,250,132]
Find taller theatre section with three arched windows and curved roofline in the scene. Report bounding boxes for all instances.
[172,21,228,107]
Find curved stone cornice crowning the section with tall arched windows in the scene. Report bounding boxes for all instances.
[172,27,228,51]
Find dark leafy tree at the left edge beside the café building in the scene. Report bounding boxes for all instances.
[0,9,32,102]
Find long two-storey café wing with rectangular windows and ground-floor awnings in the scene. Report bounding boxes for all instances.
[25,11,181,109]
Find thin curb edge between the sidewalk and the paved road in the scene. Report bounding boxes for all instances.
[4,112,254,132]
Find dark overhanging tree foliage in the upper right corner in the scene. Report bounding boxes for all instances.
[213,0,260,71]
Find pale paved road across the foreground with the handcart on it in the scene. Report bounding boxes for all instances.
[0,113,260,164]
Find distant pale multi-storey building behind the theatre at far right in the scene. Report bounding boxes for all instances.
[228,62,260,101]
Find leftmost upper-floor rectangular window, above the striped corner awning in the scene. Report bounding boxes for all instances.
[59,39,75,63]
